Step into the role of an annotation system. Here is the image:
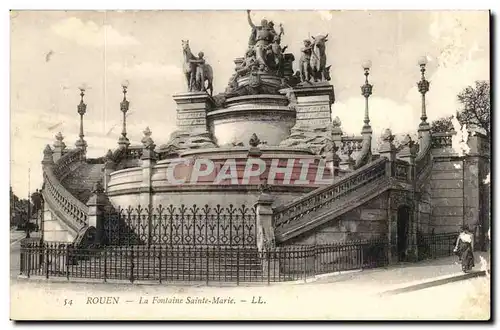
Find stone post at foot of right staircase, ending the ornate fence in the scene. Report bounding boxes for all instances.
[256,193,279,277]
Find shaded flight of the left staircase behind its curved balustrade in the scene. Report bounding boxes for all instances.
[61,162,104,204]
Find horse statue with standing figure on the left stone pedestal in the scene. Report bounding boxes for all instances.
[182,40,213,96]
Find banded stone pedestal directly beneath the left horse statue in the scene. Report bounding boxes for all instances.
[173,92,212,131]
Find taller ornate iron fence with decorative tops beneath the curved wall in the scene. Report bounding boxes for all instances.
[104,205,256,247]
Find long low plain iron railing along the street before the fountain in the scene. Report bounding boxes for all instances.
[21,241,388,284]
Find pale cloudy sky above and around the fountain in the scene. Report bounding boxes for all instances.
[10,11,490,196]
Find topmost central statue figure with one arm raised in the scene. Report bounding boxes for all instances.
[247,10,277,70]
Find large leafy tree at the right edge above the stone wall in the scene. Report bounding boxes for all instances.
[457,80,490,138]
